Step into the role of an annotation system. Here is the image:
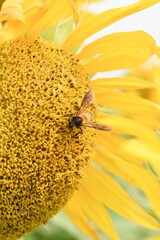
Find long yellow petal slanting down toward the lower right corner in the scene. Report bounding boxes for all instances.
[85,167,159,229]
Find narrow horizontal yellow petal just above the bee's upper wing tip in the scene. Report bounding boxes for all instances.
[91,77,155,92]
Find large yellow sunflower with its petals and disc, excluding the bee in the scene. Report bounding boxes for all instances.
[0,0,160,240]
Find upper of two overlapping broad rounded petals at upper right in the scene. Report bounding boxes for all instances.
[77,31,155,59]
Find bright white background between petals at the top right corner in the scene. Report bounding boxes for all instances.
[90,0,160,45]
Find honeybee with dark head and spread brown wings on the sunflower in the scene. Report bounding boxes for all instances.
[68,90,112,131]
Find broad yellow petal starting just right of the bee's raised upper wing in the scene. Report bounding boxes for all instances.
[95,92,160,126]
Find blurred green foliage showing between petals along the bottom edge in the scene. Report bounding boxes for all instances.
[21,211,160,240]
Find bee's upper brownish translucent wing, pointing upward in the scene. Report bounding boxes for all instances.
[77,90,94,115]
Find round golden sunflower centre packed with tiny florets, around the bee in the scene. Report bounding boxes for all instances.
[0,40,94,240]
